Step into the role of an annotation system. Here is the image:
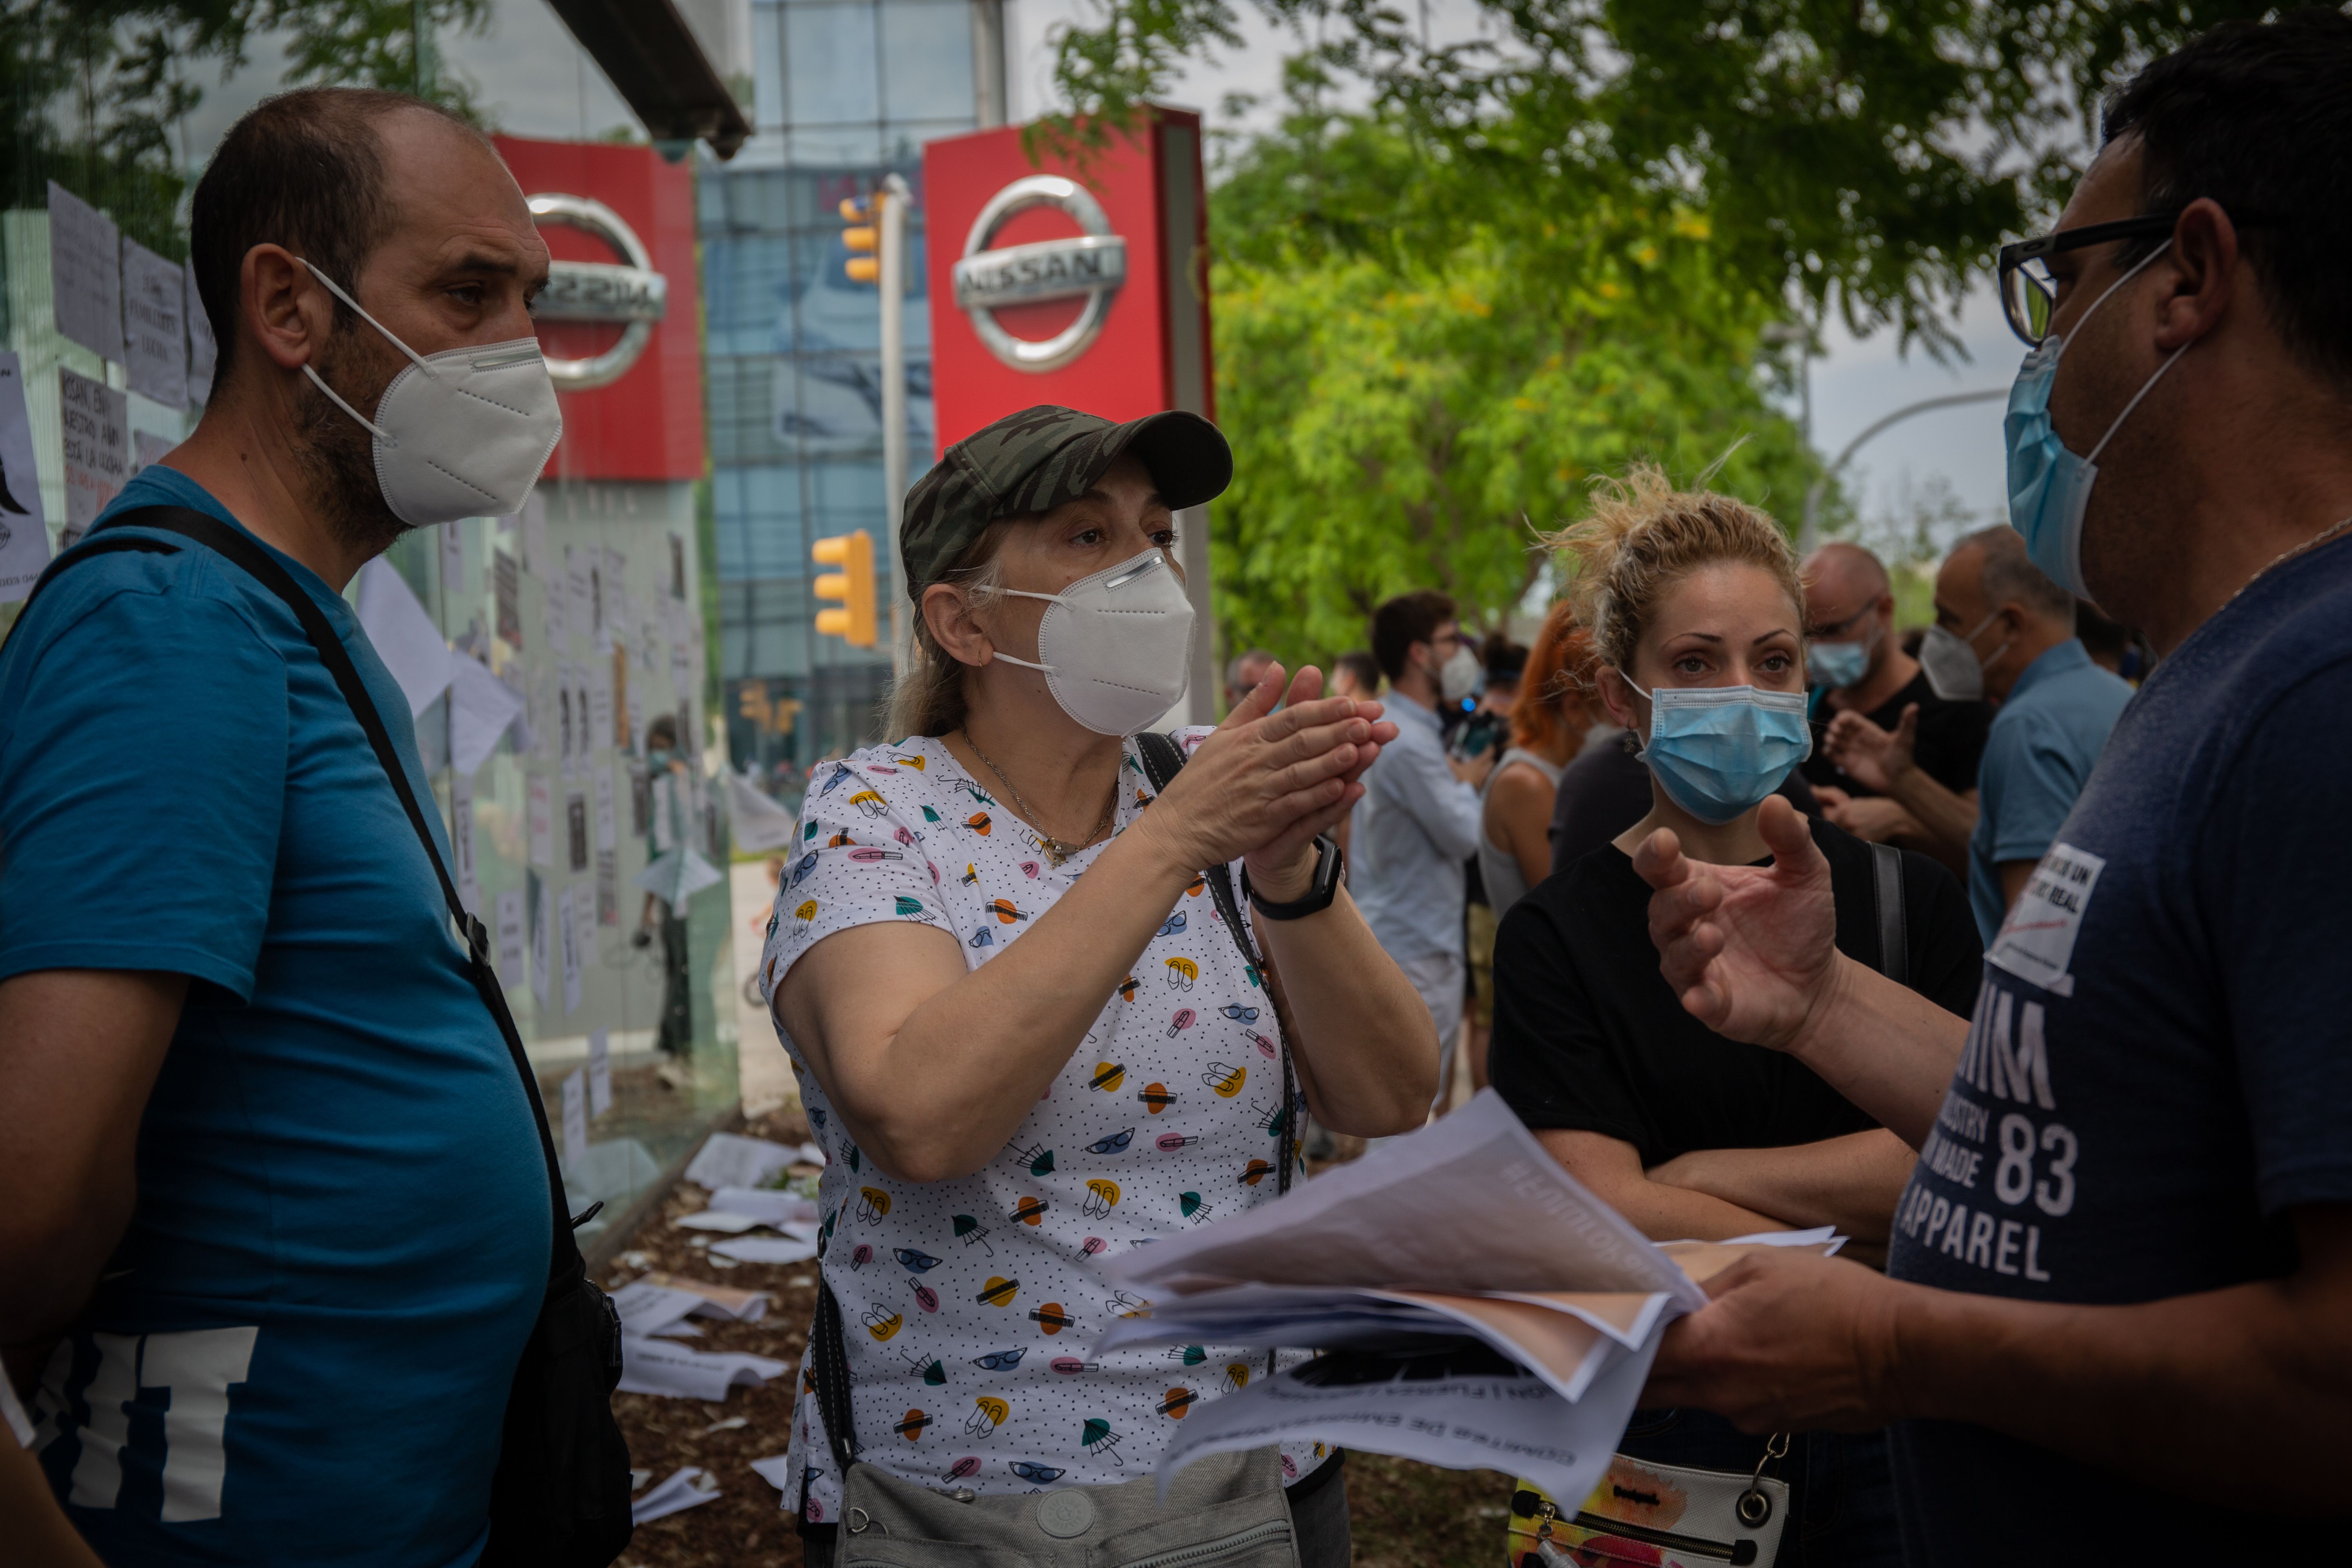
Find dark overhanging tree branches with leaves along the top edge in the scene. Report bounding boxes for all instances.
[1056,0,2267,348]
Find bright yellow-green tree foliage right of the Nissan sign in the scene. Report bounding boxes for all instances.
[1209,87,1816,663]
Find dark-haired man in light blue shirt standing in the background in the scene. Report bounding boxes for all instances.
[1348,590,1494,1114]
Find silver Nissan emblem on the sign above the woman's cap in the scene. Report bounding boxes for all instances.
[950,174,1127,374]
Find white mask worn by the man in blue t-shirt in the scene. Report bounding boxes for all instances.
[301,261,564,529]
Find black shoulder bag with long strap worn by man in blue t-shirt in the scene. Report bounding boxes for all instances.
[26,506,633,1568]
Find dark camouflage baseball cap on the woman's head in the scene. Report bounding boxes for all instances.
[898,402,1232,599]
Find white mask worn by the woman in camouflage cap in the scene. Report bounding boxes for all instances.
[997,548,1192,736]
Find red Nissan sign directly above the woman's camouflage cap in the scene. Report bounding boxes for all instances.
[922,108,1216,447]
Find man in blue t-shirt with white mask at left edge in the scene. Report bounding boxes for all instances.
[0,89,578,1566]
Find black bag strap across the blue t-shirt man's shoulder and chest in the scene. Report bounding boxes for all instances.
[53,506,576,1281]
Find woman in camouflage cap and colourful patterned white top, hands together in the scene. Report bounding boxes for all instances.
[762,407,1437,1568]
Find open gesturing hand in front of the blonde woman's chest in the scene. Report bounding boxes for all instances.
[1632,795,1837,1051]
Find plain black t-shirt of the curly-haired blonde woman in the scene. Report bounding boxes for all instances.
[1486,818,1983,1166]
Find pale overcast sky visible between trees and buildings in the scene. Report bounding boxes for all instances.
[186,0,2025,543]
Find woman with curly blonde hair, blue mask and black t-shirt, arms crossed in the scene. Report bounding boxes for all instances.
[1489,466,1978,1566]
